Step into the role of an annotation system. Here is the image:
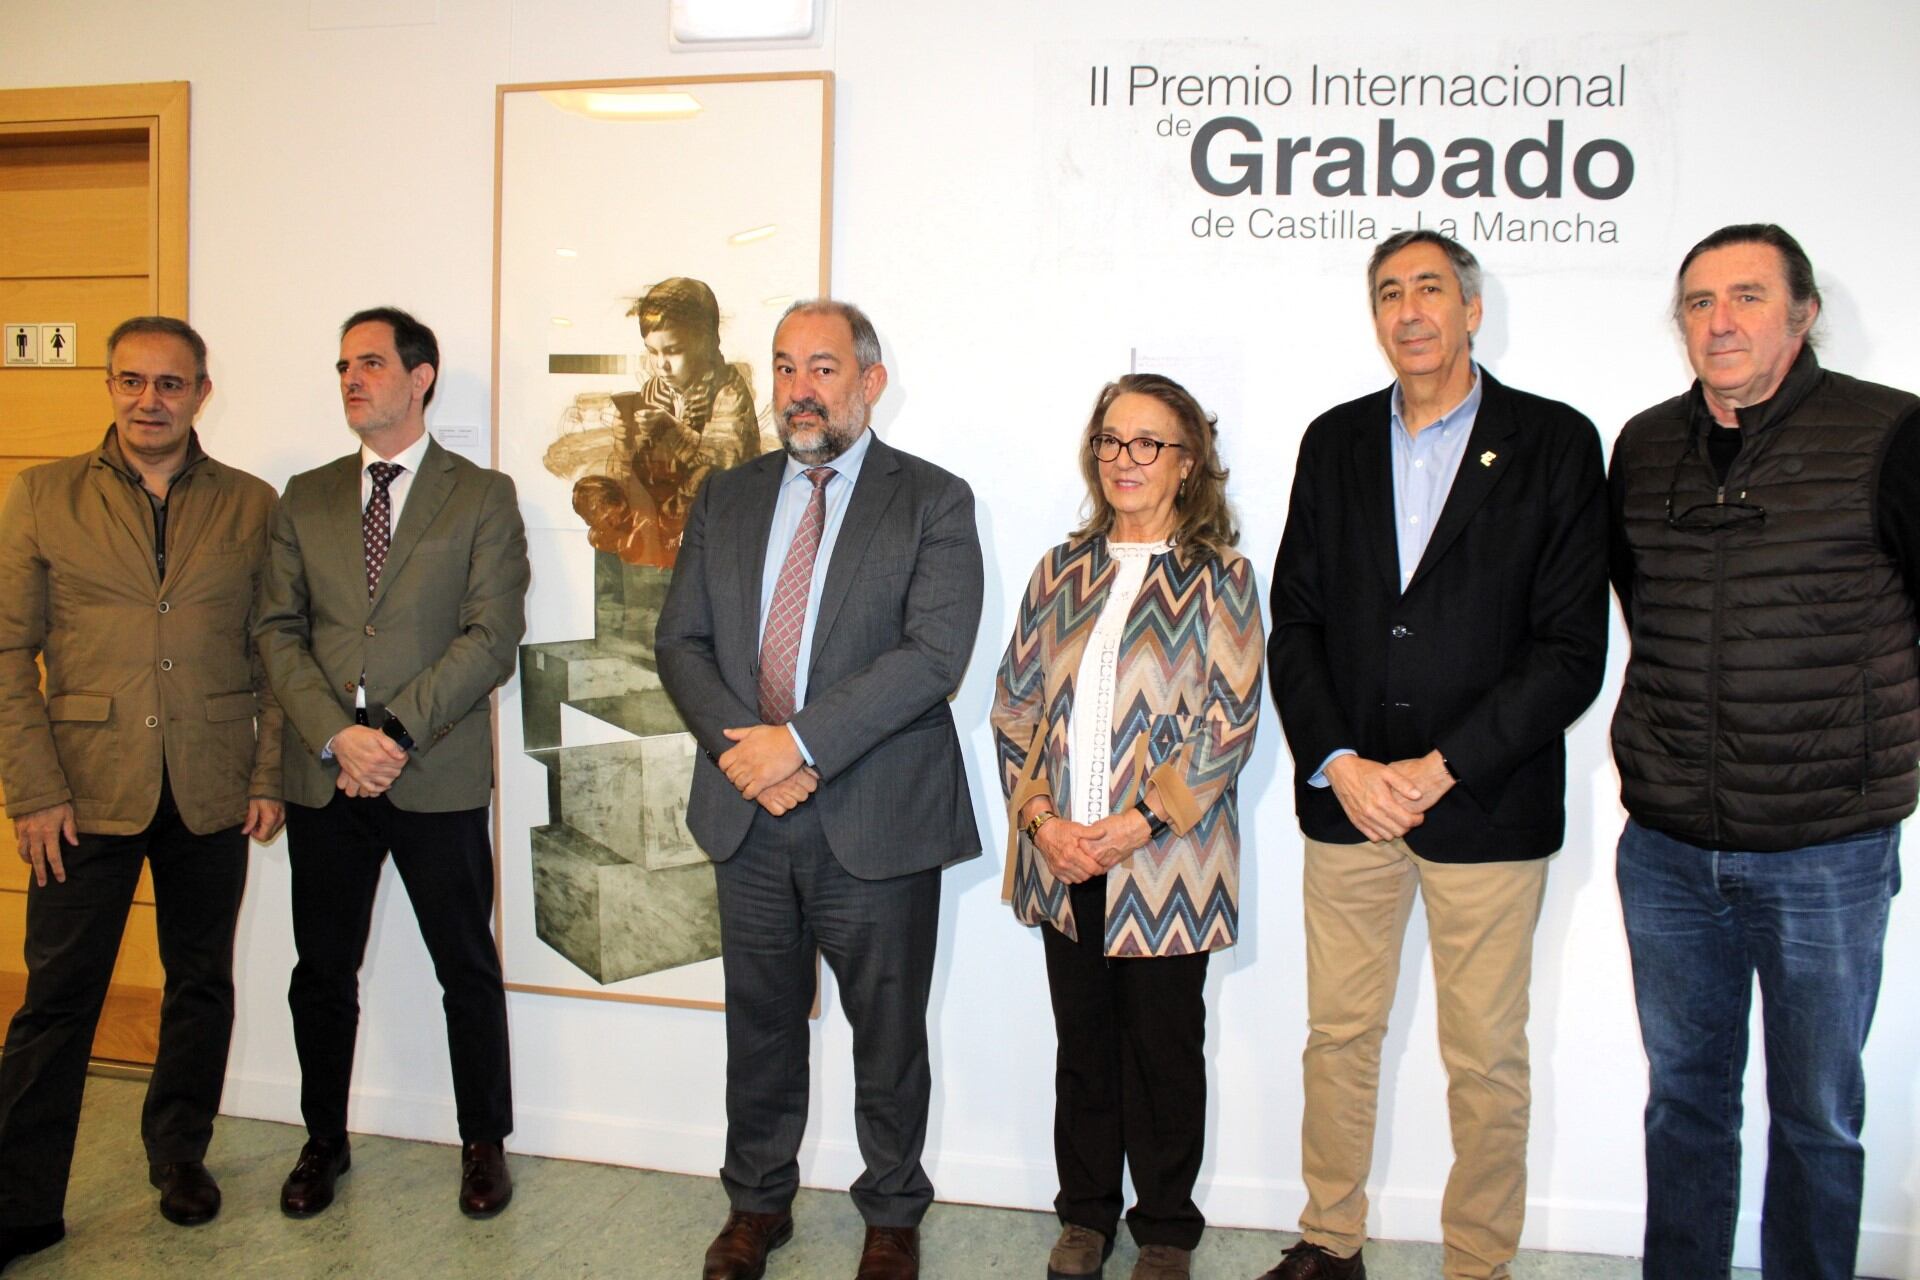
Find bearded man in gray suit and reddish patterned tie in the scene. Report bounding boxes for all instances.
[657,299,981,1280]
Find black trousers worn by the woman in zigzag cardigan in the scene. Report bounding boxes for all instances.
[1041,875,1208,1249]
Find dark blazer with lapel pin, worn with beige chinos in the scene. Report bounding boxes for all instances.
[1267,368,1607,862]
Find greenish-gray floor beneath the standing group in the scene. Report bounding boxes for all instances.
[8,1077,1749,1280]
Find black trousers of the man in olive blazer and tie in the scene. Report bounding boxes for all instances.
[286,793,513,1142]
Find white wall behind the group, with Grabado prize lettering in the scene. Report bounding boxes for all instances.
[0,0,1920,1276]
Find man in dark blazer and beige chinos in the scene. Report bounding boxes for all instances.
[1267,230,1607,1280]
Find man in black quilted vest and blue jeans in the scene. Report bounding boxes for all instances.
[1609,225,1920,1280]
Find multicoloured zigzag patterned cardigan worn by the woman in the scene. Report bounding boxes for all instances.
[993,537,1265,956]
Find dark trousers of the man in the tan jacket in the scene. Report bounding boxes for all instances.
[0,783,246,1226]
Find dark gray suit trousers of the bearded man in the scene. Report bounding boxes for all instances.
[714,804,941,1226]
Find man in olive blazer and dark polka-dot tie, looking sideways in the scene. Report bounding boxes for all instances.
[255,307,528,1217]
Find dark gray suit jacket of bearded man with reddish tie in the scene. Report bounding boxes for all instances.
[655,438,983,879]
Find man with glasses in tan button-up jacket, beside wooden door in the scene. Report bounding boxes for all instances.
[0,317,280,1267]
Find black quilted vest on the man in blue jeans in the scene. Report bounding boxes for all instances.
[1613,351,1920,850]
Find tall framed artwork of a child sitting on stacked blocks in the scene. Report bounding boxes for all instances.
[493,73,833,1009]
